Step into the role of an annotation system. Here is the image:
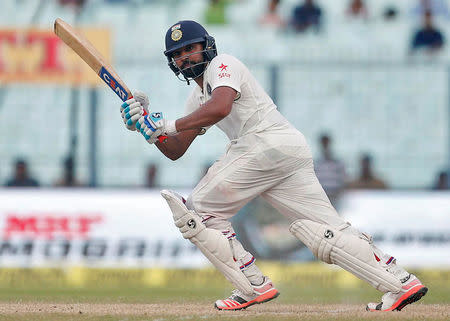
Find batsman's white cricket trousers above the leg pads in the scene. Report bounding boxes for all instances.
[188,124,347,231]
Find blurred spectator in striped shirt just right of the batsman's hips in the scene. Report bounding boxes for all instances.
[314,134,346,207]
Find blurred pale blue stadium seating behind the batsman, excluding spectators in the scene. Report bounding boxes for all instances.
[0,0,450,188]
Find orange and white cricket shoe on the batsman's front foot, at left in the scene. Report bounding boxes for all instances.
[214,276,280,310]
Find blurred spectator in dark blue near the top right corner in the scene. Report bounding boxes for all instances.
[411,11,444,53]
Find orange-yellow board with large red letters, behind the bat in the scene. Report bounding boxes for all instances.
[0,28,111,85]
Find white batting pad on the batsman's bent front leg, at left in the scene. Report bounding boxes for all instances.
[161,190,253,296]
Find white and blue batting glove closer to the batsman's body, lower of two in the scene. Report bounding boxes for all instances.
[136,112,177,144]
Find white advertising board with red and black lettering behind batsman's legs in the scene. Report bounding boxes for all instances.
[0,189,450,269]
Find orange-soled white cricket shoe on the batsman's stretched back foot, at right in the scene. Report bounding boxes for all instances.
[366,274,428,311]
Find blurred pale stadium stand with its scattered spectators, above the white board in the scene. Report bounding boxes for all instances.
[0,0,450,191]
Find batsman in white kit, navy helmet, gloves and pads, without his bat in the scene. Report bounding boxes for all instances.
[120,21,428,311]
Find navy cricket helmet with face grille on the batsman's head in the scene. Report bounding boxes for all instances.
[164,20,217,84]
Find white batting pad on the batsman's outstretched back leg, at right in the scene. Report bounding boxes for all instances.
[289,219,401,293]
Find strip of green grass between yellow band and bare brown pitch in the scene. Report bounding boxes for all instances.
[0,281,450,304]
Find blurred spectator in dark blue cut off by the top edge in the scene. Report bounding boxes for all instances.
[292,0,322,32]
